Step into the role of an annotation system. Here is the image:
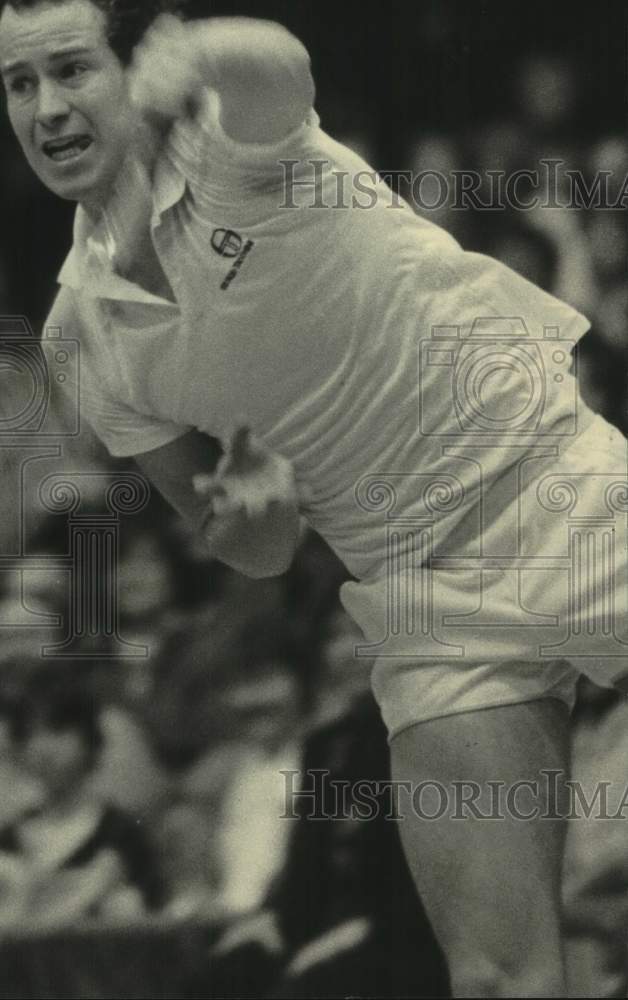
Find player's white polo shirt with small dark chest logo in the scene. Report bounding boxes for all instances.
[48,94,588,578]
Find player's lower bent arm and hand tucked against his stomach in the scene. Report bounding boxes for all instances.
[135,428,300,579]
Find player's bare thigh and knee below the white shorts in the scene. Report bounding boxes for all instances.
[391,698,568,997]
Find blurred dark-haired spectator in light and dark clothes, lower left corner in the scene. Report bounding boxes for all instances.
[1,665,163,928]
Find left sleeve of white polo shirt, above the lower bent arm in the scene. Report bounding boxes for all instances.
[46,287,189,458]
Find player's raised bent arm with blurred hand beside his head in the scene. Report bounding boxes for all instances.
[131,15,314,143]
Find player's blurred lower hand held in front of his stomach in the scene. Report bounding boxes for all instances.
[194,425,298,519]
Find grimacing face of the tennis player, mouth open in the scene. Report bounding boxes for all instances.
[0,0,136,208]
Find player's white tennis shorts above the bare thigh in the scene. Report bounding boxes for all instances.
[341,416,628,737]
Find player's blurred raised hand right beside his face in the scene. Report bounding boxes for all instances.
[130,14,204,129]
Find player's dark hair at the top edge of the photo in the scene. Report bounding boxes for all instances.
[0,0,186,66]
